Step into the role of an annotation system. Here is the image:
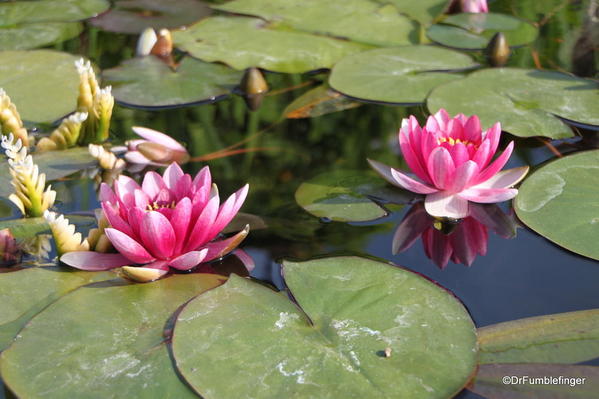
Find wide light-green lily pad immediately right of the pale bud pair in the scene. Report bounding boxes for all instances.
[173,17,369,73]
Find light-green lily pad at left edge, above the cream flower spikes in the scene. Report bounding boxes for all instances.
[0,50,80,123]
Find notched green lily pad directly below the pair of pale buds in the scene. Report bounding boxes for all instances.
[102,56,241,108]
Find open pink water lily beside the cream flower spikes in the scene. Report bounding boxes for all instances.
[61,163,249,274]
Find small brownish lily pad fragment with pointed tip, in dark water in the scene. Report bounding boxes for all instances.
[283,83,361,119]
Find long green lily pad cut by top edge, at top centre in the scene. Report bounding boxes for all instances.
[214,0,417,46]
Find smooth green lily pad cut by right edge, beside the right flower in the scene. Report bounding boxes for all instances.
[515,150,599,260]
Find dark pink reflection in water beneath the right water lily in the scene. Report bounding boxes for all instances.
[393,202,516,269]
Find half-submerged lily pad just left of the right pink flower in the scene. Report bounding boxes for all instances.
[295,170,412,222]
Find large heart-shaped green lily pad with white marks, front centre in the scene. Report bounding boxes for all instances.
[172,257,476,399]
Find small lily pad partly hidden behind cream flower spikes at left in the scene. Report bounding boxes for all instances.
[0,147,96,197]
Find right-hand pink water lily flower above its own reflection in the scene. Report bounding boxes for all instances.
[368,109,528,219]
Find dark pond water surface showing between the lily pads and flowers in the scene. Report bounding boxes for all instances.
[3,0,599,398]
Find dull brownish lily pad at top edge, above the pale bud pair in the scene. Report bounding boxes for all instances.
[90,0,211,33]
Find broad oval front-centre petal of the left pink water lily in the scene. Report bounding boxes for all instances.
[140,211,176,259]
